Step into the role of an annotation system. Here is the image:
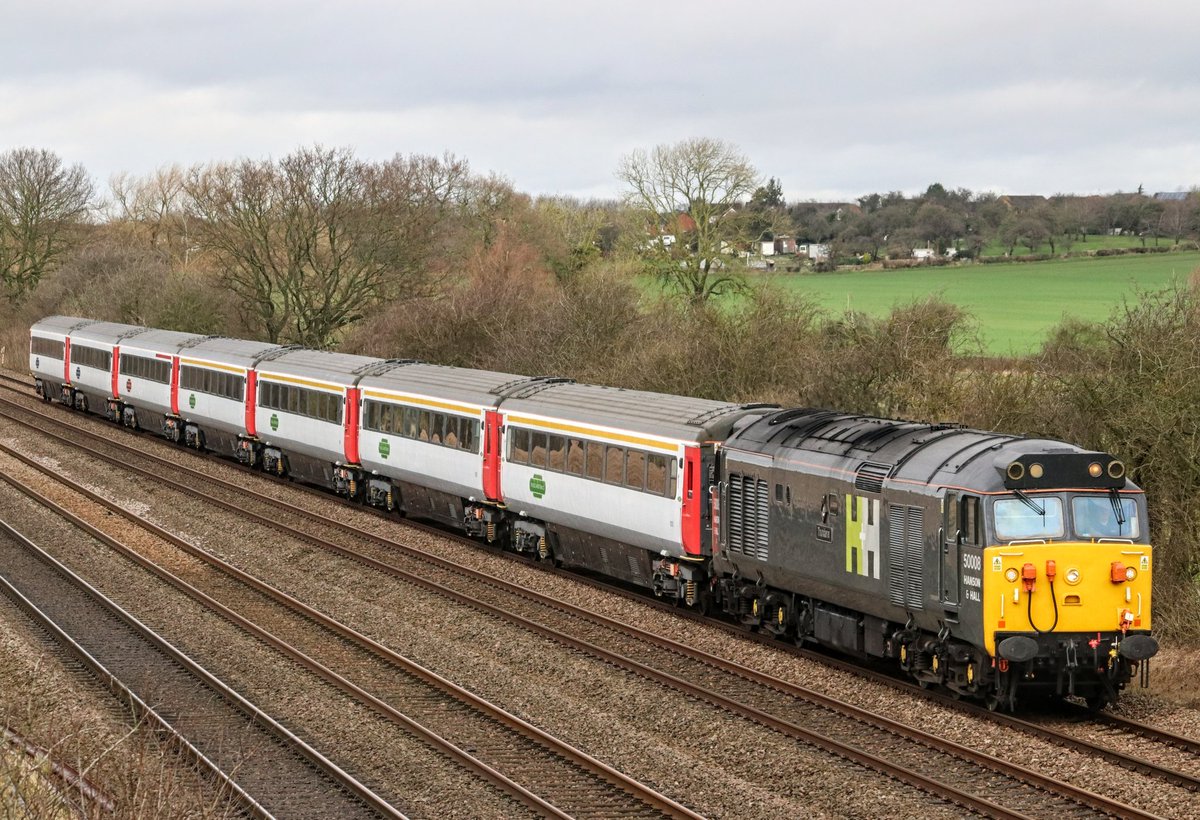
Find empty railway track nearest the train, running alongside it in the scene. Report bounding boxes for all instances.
[0,379,1185,816]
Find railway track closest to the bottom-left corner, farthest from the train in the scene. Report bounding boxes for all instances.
[0,521,403,818]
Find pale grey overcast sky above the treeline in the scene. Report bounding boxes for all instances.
[0,0,1200,200]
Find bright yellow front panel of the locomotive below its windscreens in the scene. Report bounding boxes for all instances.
[983,541,1153,657]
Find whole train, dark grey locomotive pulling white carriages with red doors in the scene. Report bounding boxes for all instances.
[29,316,1158,710]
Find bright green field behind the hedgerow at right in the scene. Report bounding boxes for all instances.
[770,252,1200,355]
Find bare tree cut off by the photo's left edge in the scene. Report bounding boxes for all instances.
[0,148,92,301]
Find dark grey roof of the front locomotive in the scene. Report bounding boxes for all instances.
[727,409,1132,492]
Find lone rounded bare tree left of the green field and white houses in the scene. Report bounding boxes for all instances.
[617,138,761,301]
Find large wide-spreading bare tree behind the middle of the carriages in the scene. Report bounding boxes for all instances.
[186,146,468,347]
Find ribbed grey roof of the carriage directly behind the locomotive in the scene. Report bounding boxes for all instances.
[500,379,774,442]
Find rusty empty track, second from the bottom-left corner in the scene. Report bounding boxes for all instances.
[0,447,697,818]
